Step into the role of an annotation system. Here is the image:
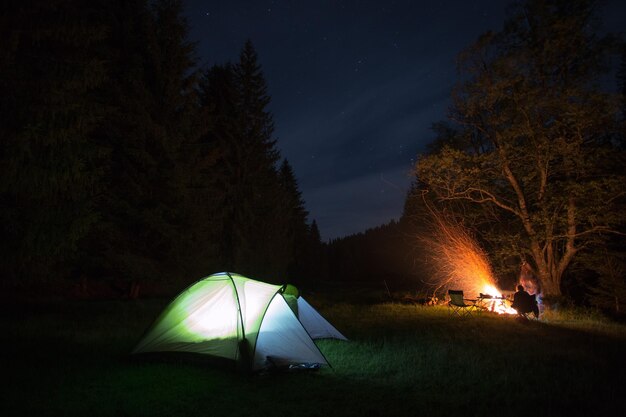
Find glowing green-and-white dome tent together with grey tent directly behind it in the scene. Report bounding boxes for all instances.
[133,272,345,370]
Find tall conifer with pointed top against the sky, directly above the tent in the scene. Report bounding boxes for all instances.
[213,41,291,281]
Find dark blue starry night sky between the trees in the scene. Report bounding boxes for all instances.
[179,0,626,240]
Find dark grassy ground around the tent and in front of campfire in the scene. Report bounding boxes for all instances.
[0,300,626,417]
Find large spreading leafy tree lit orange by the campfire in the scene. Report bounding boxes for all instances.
[416,0,624,295]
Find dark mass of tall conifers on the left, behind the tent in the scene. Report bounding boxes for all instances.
[0,0,326,292]
